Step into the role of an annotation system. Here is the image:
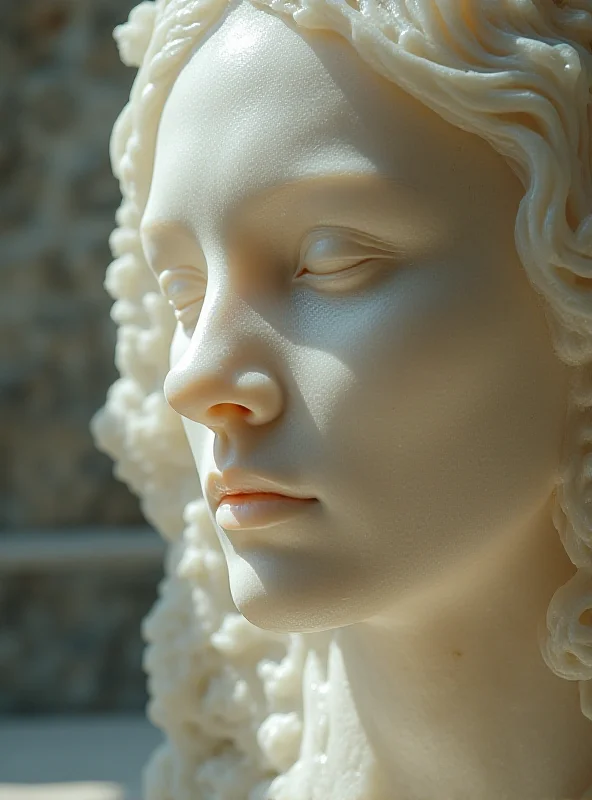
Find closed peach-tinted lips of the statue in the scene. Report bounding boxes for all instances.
[205,468,318,531]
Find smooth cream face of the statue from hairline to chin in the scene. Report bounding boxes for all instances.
[143,3,565,630]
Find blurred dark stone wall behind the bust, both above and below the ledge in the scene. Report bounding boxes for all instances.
[0,0,160,712]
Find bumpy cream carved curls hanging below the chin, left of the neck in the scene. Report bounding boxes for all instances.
[144,501,302,800]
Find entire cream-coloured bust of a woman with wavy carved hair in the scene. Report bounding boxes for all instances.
[94,0,592,800]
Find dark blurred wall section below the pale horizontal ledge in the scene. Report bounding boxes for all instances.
[0,569,160,716]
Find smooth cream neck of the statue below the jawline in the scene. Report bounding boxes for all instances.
[280,500,592,800]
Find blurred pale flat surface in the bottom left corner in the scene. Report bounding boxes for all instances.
[0,715,160,800]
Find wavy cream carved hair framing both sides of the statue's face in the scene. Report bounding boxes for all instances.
[94,0,592,800]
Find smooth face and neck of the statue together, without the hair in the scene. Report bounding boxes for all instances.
[141,3,592,800]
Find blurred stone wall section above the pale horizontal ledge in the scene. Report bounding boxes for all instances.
[0,0,141,535]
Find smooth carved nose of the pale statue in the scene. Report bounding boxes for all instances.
[165,284,283,427]
